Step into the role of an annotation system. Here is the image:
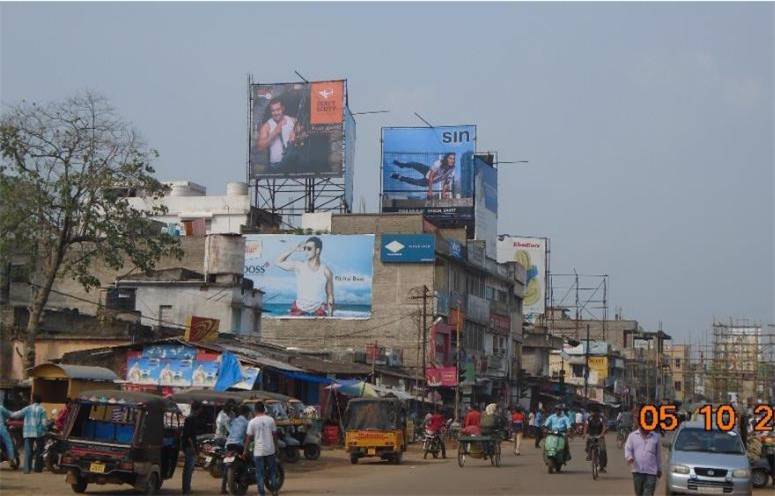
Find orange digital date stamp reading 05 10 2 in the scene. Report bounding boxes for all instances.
[638,404,775,432]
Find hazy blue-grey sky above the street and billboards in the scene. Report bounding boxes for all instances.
[0,2,775,342]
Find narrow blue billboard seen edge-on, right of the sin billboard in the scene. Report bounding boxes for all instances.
[474,155,498,260]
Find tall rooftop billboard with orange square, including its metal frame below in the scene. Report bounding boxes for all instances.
[246,76,356,228]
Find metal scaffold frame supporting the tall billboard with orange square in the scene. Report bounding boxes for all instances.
[245,73,354,229]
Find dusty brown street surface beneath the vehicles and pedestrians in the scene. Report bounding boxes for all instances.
[0,435,768,496]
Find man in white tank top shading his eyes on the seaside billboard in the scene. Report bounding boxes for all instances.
[276,236,334,317]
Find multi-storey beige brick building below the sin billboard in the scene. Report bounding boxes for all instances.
[262,214,525,408]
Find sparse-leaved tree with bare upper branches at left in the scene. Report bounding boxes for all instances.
[0,92,181,370]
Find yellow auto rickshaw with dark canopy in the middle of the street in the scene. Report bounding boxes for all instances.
[345,398,406,464]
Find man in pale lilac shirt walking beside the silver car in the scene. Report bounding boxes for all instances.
[624,408,662,496]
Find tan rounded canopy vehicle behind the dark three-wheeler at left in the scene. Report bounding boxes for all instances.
[30,363,120,418]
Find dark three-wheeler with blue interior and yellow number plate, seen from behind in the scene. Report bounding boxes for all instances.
[61,390,184,494]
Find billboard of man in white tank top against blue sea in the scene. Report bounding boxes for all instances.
[245,234,374,319]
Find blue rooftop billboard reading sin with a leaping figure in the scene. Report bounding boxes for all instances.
[382,125,476,227]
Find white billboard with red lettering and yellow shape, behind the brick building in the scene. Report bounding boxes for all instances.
[498,236,546,322]
